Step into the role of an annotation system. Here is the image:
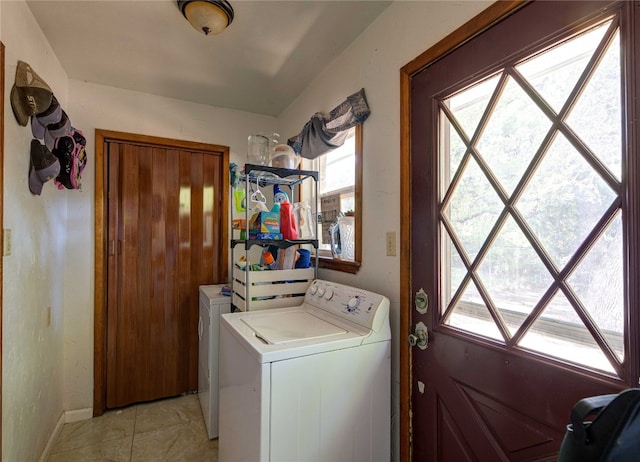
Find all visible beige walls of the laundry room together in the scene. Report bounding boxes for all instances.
[0,0,491,461]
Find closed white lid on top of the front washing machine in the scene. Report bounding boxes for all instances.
[242,311,347,345]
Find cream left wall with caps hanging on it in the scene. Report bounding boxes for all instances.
[0,2,73,461]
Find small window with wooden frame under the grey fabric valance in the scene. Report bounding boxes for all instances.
[312,125,362,273]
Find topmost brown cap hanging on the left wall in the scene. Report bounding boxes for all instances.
[11,61,53,127]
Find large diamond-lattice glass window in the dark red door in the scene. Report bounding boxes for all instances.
[438,18,626,375]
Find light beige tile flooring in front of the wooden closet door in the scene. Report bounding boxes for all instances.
[49,394,218,462]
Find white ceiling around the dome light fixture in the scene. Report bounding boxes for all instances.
[27,0,391,116]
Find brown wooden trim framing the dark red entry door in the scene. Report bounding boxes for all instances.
[400,0,529,461]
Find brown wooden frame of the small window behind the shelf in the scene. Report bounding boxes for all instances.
[317,124,363,274]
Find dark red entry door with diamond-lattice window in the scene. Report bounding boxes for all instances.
[409,2,640,462]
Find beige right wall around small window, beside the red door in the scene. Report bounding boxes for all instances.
[278,1,492,460]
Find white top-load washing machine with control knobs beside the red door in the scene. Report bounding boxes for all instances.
[219,280,391,462]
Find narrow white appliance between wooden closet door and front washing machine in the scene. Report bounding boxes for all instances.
[198,285,231,438]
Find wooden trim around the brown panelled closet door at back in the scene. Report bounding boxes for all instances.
[92,129,229,416]
